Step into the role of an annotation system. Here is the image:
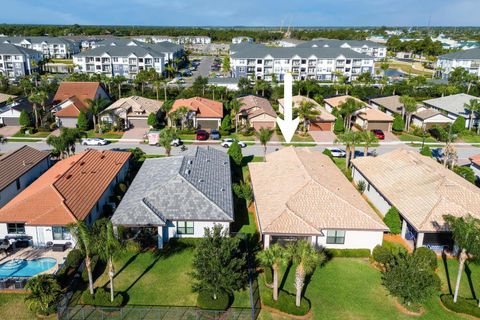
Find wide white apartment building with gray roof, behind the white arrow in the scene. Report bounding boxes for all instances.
[230,44,374,81]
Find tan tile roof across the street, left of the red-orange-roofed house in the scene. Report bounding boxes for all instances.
[104,96,163,117]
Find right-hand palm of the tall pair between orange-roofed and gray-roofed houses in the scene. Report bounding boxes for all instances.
[95,219,122,302]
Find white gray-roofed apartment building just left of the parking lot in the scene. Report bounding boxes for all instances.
[73,45,166,79]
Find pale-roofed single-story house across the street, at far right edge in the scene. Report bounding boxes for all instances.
[423,93,480,128]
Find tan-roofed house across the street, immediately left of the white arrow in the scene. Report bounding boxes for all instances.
[236,95,277,130]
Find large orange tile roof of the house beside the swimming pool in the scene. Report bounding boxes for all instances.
[0,149,130,226]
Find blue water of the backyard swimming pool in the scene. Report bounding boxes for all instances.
[0,258,57,278]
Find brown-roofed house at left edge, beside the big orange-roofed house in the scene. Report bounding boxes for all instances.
[0,146,50,208]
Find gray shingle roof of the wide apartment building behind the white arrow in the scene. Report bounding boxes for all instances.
[232,45,372,59]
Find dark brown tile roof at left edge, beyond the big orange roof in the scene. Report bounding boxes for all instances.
[0,146,50,191]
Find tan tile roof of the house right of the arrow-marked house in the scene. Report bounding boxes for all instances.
[353,149,480,232]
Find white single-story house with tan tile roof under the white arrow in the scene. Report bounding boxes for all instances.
[248,147,387,250]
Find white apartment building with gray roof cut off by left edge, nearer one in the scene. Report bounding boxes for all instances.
[0,43,42,79]
